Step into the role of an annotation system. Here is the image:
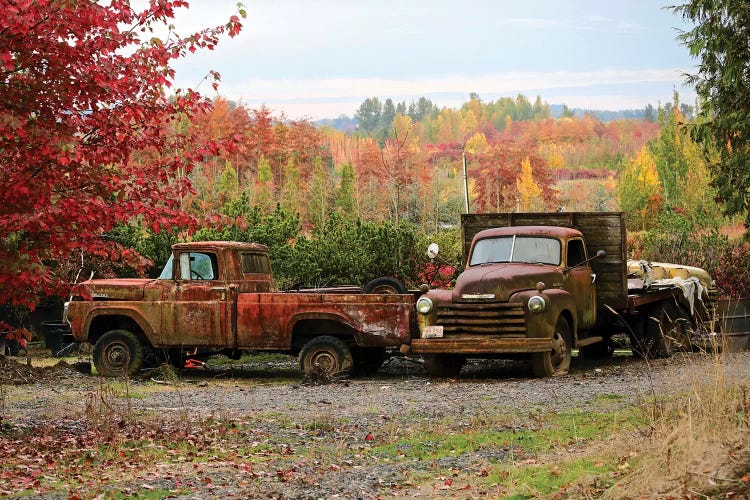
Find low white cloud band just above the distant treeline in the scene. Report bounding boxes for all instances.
[207,68,690,119]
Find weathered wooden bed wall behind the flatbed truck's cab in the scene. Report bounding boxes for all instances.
[461,212,628,309]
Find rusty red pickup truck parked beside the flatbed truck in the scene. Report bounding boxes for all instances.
[63,241,415,376]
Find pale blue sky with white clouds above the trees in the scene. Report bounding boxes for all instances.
[164,0,695,119]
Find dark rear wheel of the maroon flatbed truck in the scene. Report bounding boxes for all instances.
[642,300,695,358]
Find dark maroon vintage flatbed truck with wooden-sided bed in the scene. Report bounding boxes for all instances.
[409,212,711,376]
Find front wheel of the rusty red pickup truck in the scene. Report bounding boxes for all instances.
[93,330,143,377]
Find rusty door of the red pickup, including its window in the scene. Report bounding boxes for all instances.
[161,251,231,347]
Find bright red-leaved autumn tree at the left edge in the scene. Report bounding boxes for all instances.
[0,0,245,307]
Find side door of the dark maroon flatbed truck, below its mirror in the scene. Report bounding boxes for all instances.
[563,239,596,330]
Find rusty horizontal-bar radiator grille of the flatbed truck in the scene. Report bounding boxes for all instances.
[437,303,526,337]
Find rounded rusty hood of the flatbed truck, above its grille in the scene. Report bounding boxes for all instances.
[453,262,562,302]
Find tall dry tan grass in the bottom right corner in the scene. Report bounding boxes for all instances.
[606,354,750,498]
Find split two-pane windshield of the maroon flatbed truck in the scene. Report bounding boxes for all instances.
[469,236,560,266]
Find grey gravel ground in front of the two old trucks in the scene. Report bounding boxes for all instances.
[2,352,750,498]
